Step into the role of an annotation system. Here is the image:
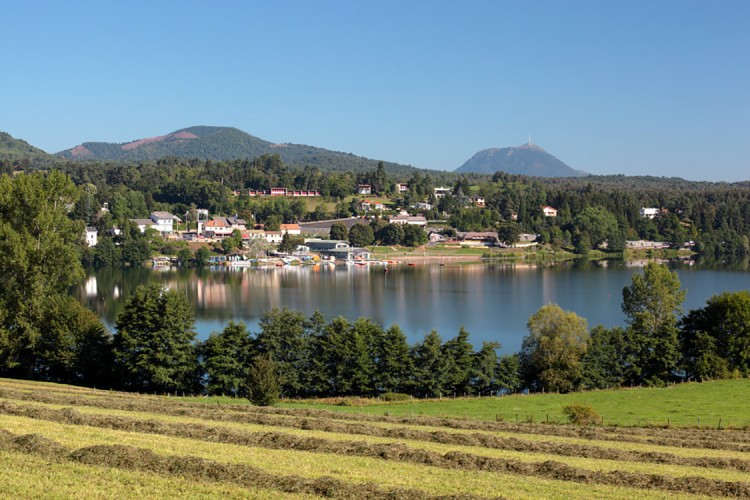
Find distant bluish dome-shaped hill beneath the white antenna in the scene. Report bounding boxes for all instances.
[456,143,588,177]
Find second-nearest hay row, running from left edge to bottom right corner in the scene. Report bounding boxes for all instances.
[0,402,750,496]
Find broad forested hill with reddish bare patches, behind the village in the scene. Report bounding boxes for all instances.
[57,127,426,175]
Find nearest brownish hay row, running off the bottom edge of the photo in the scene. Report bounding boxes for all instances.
[0,429,464,500]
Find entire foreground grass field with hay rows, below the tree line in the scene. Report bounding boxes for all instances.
[0,379,750,498]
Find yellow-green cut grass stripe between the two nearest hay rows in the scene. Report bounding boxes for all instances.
[0,417,708,499]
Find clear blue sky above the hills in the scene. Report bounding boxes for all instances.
[0,0,750,181]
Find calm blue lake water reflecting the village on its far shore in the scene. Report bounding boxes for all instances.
[75,262,750,352]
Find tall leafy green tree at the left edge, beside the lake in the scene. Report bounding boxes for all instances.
[0,171,89,378]
